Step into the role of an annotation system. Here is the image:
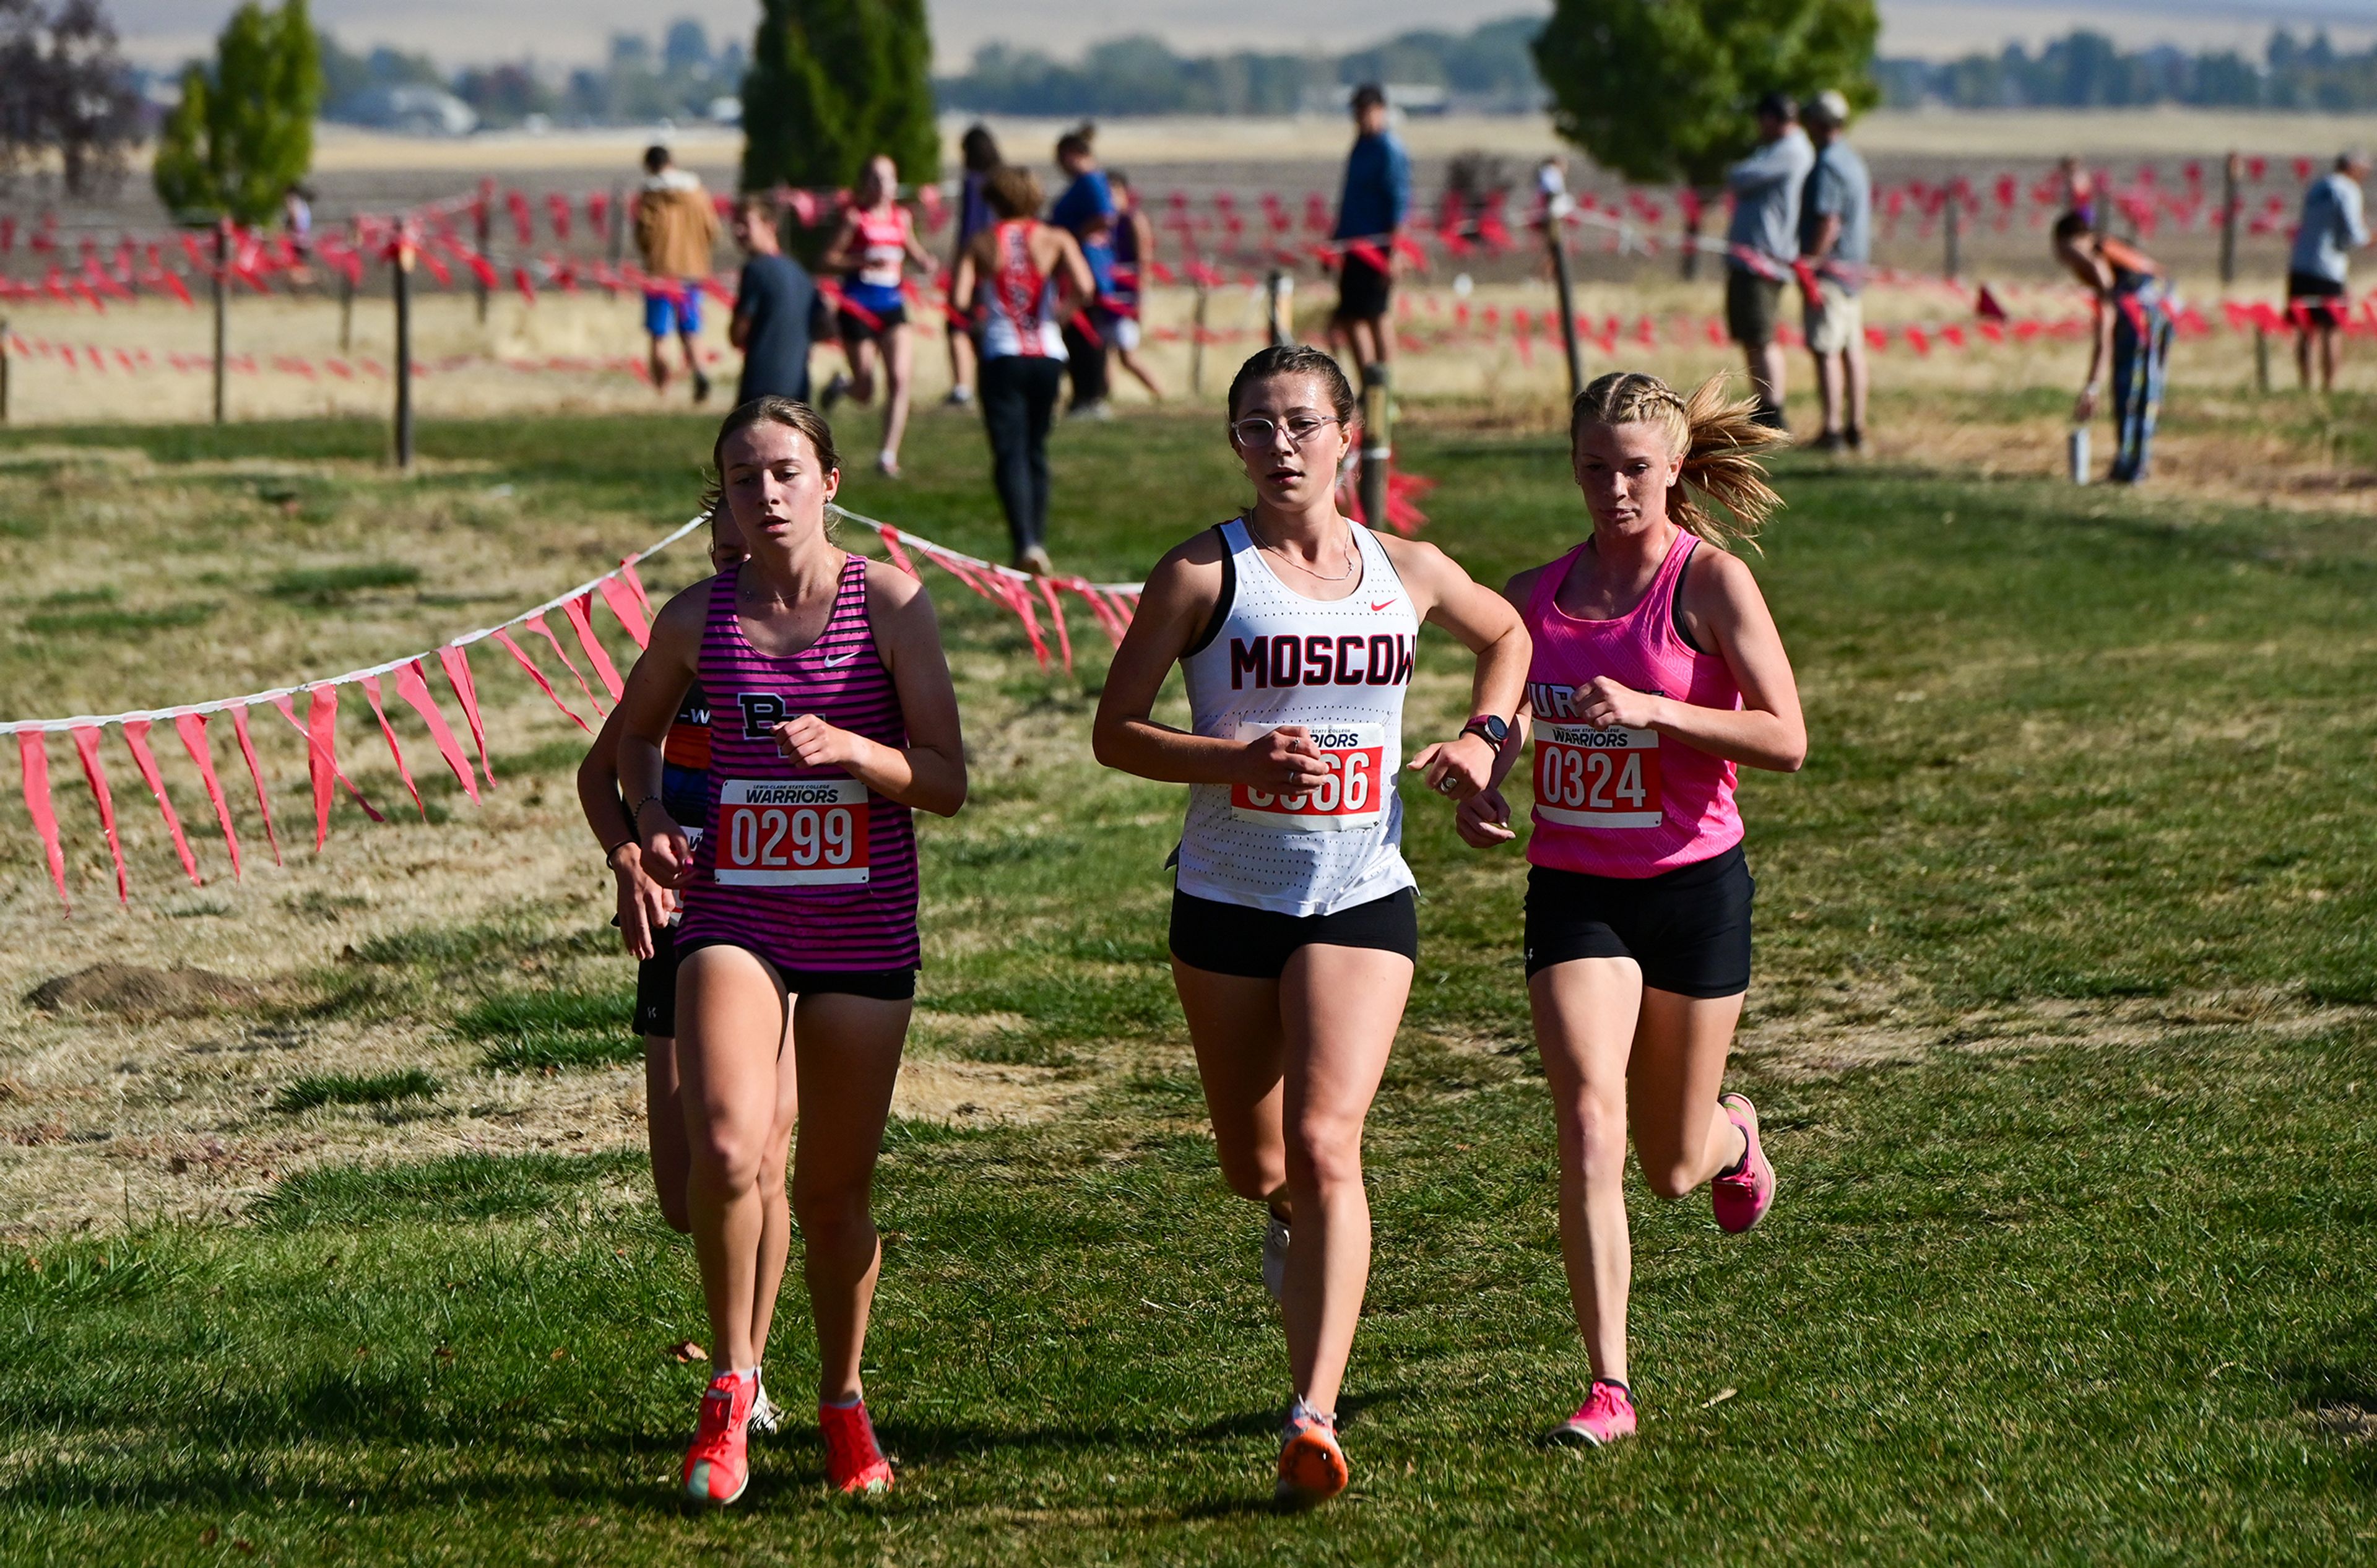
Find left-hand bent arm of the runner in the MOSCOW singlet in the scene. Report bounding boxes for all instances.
[1089,535,1329,791]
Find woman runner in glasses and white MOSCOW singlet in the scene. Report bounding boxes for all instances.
[1096,347,1528,1502]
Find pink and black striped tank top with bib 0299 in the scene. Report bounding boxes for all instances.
[677,556,917,974]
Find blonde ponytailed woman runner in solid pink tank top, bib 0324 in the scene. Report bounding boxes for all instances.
[1460,375,1806,1447]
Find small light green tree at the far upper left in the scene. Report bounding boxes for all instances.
[155,0,323,223]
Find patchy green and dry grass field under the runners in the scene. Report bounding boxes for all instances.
[0,399,2377,1563]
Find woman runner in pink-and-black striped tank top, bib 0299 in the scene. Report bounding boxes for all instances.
[618,397,965,1504]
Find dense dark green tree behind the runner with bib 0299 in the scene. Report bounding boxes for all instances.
[742,0,942,202]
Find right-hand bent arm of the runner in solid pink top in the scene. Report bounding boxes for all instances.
[1583,549,1806,772]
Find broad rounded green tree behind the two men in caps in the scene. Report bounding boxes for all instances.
[1536,0,1882,259]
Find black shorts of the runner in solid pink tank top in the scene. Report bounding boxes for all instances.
[1526,843,1757,998]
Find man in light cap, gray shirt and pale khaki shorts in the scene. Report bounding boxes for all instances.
[1799,93,1873,451]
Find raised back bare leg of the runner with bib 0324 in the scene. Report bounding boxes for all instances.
[1626,986,1749,1197]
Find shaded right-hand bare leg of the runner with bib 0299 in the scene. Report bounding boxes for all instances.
[792,990,915,1404]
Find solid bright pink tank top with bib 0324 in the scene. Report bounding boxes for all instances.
[1526,530,1743,877]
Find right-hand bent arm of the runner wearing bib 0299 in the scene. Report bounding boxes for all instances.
[775,561,965,817]
